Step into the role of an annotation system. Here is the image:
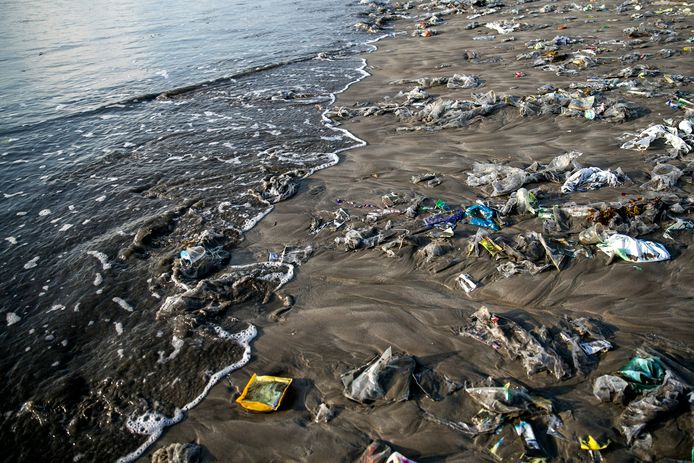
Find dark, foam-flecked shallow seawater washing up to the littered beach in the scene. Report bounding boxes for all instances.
[0,1,386,461]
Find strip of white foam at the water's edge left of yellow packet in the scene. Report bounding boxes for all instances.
[117,325,258,463]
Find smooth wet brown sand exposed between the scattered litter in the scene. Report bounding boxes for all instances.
[149,2,694,462]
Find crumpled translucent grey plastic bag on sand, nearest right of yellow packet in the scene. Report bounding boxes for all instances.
[340,347,415,404]
